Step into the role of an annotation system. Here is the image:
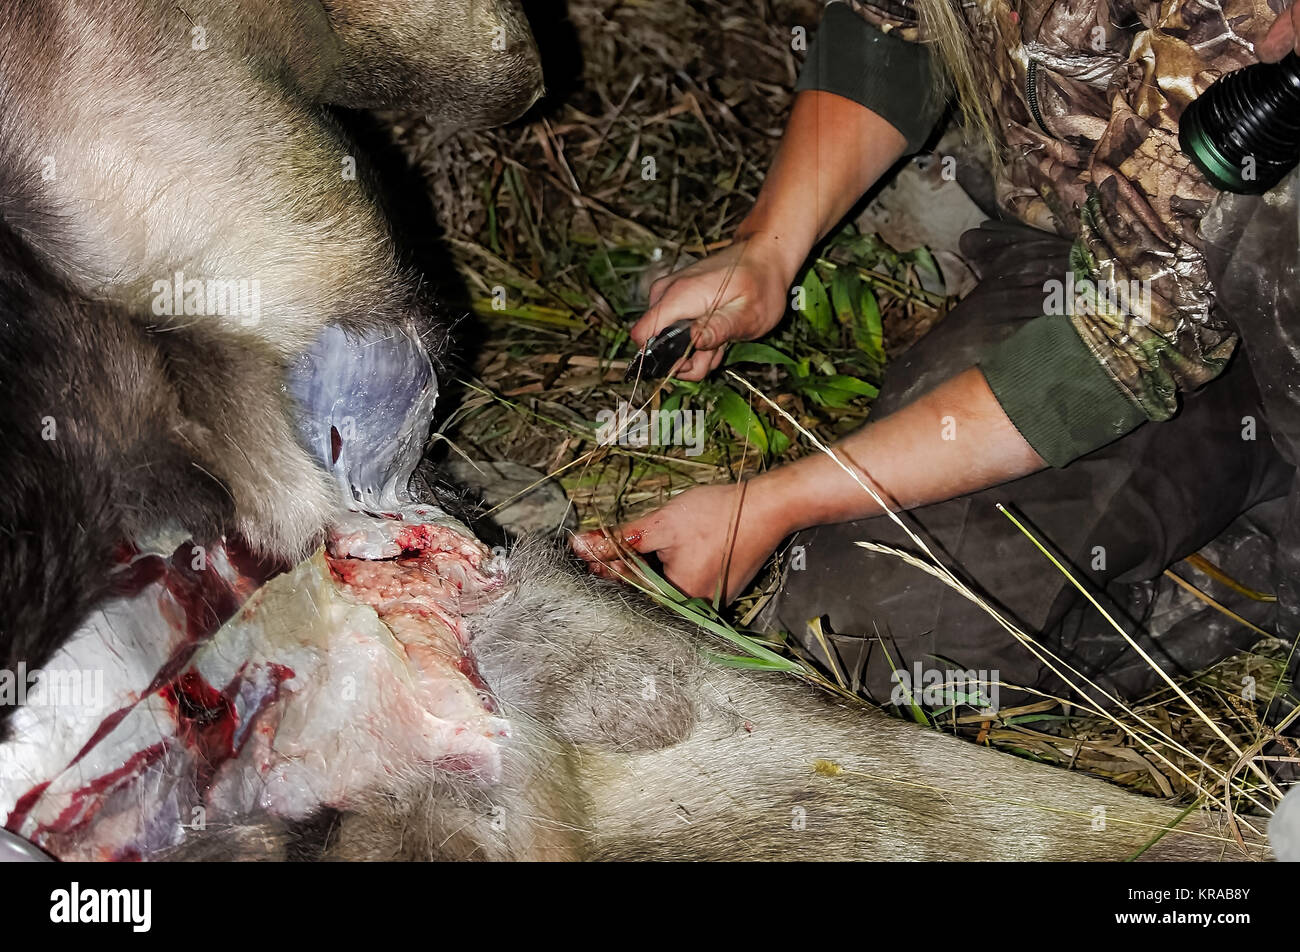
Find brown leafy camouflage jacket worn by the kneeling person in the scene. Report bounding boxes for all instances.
[801,0,1281,464]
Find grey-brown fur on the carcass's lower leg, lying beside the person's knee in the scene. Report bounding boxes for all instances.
[165,544,1262,862]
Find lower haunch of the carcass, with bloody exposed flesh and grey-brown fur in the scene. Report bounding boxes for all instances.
[0,507,1260,861]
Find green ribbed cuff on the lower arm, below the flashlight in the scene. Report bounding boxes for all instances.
[980,315,1147,467]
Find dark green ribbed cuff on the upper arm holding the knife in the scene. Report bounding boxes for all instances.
[794,3,945,155]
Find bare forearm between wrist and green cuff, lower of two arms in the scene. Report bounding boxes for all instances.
[749,368,1045,535]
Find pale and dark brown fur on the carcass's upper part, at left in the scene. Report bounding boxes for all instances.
[0,0,541,686]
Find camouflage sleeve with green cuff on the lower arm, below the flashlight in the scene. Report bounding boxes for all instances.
[980,178,1236,467]
